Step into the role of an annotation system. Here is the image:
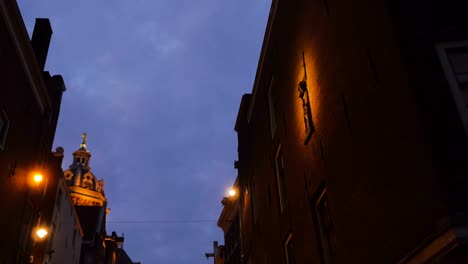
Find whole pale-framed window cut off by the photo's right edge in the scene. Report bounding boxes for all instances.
[437,41,468,134]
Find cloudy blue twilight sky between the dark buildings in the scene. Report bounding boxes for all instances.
[18,0,271,264]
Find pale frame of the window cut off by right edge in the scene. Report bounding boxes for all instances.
[436,41,468,135]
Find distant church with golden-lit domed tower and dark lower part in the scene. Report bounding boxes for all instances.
[64,136,138,264]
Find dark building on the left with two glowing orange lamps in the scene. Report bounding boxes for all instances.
[0,1,65,264]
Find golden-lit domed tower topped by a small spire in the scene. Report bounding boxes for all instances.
[64,133,107,206]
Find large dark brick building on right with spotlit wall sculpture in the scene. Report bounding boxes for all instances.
[220,0,468,264]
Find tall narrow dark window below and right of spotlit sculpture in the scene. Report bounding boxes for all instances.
[315,188,333,264]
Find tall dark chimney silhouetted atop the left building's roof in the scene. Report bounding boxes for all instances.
[31,18,52,71]
